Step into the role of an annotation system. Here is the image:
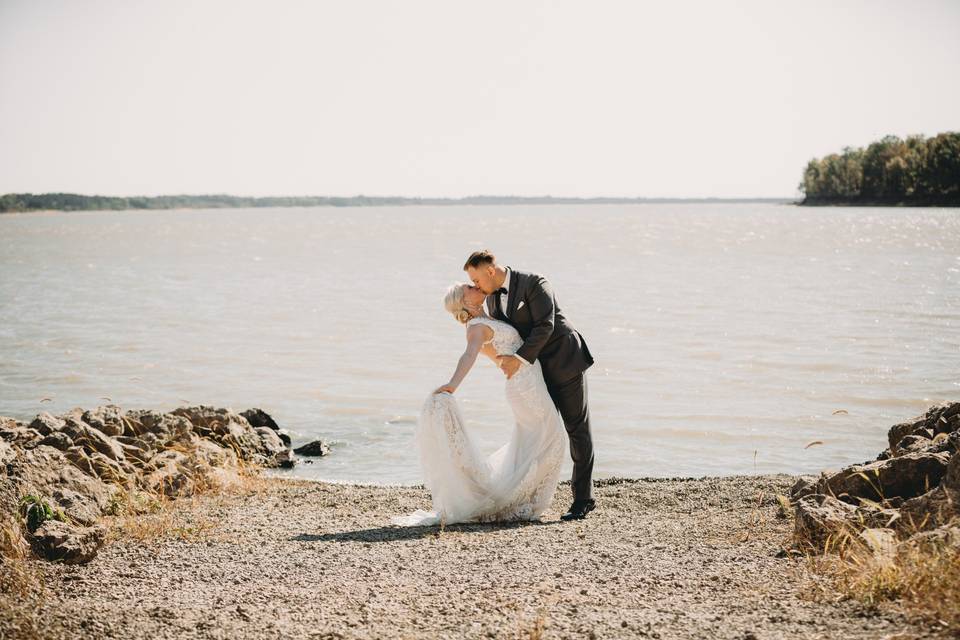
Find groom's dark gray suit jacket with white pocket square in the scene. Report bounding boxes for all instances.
[487,267,593,385]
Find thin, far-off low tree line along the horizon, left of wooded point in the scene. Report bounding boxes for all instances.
[0,193,789,213]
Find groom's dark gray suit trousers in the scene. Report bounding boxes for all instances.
[547,373,593,500]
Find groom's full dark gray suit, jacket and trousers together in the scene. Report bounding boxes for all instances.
[487,269,593,500]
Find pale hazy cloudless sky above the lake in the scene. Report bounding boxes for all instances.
[0,0,960,197]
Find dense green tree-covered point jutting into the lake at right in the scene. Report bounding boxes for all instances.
[800,132,960,206]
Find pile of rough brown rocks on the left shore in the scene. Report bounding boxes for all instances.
[0,405,308,563]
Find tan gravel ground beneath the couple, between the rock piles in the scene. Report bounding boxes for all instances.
[18,475,940,640]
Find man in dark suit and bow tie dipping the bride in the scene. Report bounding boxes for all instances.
[463,250,595,520]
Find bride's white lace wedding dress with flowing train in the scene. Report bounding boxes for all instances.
[391,317,567,526]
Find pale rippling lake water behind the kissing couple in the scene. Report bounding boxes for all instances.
[0,204,960,484]
